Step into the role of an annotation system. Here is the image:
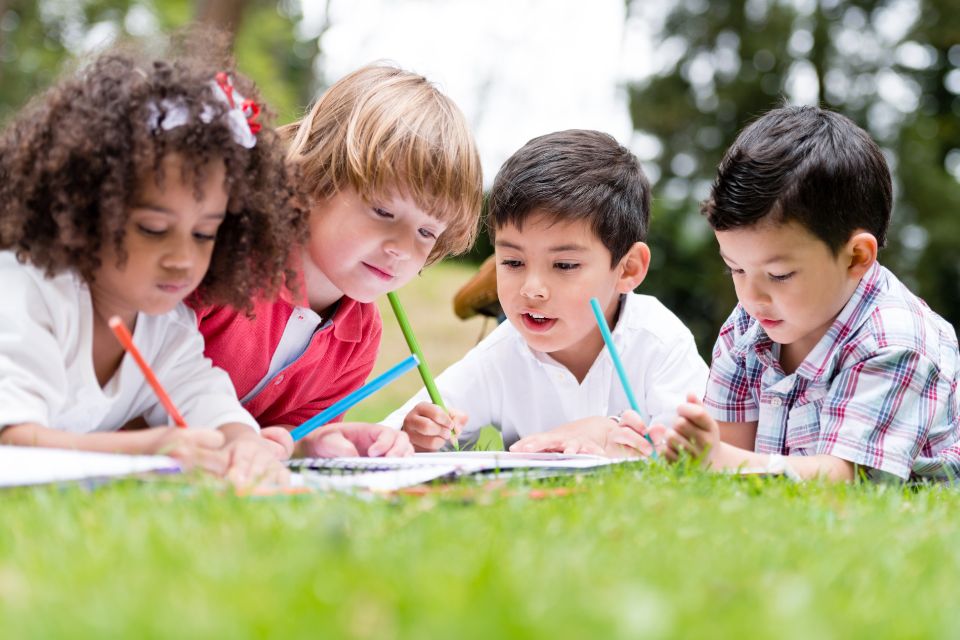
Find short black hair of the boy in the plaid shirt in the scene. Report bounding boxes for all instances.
[701,106,893,254]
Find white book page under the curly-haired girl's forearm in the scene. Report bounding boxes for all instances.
[0,446,180,487]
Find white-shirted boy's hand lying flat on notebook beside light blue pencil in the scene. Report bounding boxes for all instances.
[510,414,652,458]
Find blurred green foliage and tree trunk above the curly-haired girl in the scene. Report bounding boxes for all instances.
[0,0,326,123]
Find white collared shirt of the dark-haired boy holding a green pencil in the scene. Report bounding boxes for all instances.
[383,293,708,446]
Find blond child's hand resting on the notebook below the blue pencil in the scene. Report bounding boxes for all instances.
[300,422,413,458]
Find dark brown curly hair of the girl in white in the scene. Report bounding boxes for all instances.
[0,34,307,310]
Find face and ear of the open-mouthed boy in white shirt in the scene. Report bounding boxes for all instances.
[494,212,649,373]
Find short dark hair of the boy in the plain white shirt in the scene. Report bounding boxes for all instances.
[487,129,650,265]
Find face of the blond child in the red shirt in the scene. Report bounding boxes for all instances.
[304,189,446,310]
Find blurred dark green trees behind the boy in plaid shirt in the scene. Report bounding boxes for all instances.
[628,0,960,355]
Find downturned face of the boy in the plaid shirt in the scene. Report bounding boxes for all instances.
[716,221,869,365]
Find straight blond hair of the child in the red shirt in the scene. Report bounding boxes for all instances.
[280,64,483,264]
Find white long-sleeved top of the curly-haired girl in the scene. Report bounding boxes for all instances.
[0,251,259,433]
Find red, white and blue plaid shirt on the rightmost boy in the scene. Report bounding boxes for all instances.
[704,264,960,479]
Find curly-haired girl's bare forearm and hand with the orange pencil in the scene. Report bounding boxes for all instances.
[0,423,229,475]
